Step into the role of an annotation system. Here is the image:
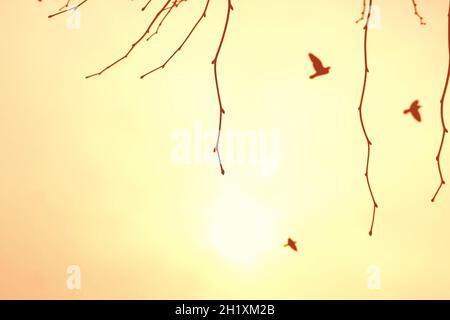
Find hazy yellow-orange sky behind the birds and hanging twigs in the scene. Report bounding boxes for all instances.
[0,0,450,299]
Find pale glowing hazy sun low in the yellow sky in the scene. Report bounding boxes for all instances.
[210,186,279,264]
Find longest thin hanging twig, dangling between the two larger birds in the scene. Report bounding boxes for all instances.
[358,0,378,236]
